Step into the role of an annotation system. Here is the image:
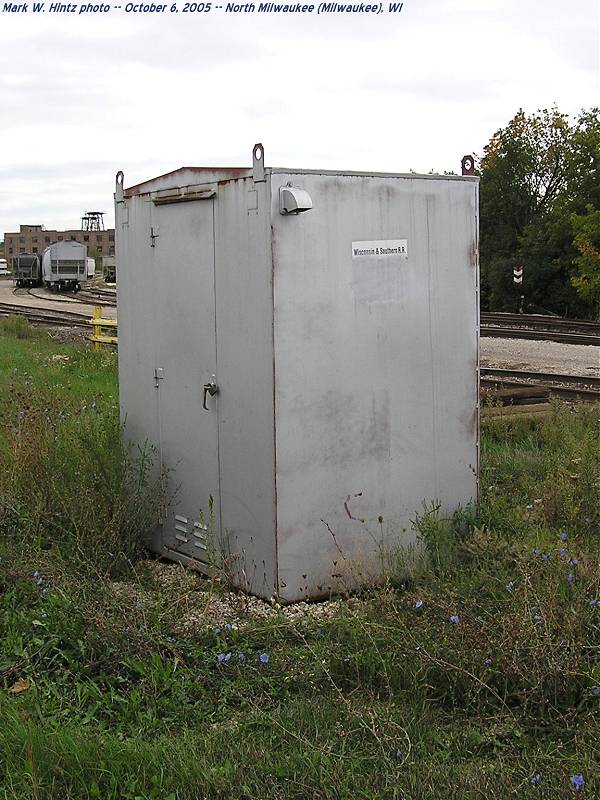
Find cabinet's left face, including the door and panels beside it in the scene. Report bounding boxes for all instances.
[116,175,277,597]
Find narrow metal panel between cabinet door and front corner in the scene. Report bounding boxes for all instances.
[214,178,277,597]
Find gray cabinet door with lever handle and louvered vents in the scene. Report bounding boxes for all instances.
[151,199,220,563]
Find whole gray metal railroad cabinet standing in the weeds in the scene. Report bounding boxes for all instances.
[116,146,479,601]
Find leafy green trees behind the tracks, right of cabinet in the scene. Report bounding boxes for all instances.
[480,108,600,316]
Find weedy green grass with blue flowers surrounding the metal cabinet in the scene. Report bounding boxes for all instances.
[0,322,600,800]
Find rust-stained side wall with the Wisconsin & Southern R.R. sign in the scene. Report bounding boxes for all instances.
[272,173,478,600]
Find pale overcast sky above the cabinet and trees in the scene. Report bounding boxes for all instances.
[0,0,600,238]
